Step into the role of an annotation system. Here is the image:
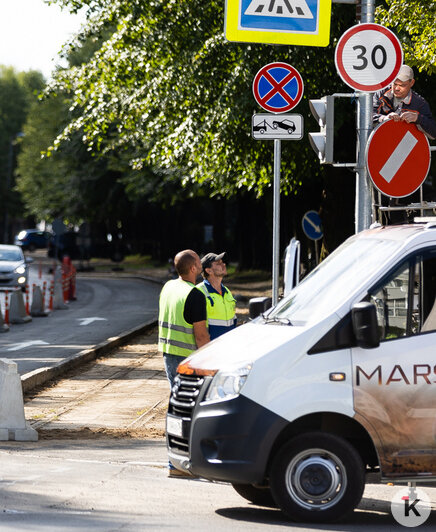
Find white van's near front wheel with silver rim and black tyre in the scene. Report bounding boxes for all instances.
[270,432,365,523]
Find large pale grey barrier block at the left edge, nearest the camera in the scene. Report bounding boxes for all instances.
[0,358,38,441]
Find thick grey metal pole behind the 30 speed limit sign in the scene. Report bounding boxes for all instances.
[355,0,374,233]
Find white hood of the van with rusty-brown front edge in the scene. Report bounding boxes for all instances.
[179,322,318,375]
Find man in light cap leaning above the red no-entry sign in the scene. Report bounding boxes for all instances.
[373,65,436,139]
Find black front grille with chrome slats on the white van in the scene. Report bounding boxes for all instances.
[168,374,205,456]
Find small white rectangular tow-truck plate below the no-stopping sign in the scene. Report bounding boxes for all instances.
[251,114,303,140]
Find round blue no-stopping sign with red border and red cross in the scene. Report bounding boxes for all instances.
[253,63,304,113]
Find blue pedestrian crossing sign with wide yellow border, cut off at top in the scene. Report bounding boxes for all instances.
[225,0,332,46]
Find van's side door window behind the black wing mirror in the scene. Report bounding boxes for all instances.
[369,250,436,340]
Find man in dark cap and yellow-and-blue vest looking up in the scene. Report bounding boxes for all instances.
[197,252,236,340]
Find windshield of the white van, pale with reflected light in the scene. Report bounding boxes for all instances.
[267,238,402,325]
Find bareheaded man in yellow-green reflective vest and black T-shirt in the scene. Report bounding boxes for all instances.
[159,249,209,387]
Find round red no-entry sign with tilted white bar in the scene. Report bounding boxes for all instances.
[366,120,430,198]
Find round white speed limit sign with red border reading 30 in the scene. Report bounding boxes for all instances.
[335,23,403,92]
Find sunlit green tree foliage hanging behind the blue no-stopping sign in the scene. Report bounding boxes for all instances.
[44,0,354,204]
